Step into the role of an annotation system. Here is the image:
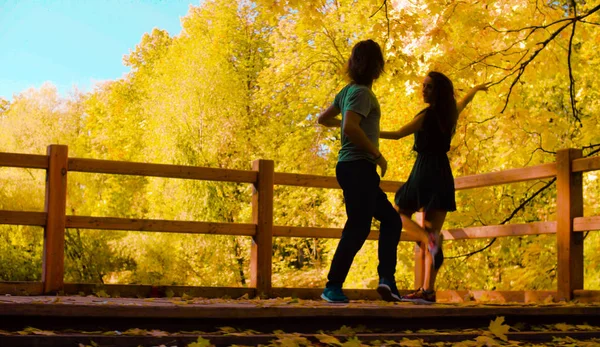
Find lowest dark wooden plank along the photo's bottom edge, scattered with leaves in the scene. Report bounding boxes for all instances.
[7,330,600,347]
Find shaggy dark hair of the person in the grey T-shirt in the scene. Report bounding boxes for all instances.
[347,40,384,86]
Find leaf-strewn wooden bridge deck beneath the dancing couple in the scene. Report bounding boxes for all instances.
[0,296,600,346]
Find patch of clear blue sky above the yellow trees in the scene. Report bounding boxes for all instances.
[0,0,200,100]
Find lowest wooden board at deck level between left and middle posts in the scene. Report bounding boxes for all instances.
[65,283,256,299]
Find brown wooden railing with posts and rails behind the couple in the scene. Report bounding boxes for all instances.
[0,145,600,300]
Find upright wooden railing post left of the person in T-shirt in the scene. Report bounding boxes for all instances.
[250,159,275,297]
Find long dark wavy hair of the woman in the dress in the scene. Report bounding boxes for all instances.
[427,71,458,135]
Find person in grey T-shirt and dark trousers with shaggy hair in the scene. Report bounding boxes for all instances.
[319,40,402,303]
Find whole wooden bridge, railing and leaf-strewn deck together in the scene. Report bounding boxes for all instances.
[0,145,600,346]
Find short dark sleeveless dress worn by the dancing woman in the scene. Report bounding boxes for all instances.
[395,108,456,211]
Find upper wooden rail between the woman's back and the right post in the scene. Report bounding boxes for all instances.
[454,163,556,190]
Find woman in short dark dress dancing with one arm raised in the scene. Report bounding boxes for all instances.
[381,71,488,304]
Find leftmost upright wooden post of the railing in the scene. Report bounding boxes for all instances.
[42,145,69,294]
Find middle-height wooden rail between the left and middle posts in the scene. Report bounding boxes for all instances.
[66,216,256,236]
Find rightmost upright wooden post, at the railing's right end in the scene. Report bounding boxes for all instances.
[556,149,583,300]
